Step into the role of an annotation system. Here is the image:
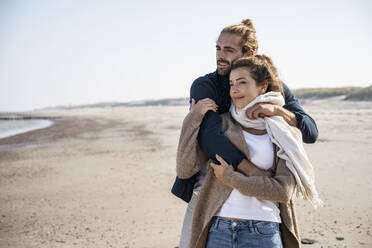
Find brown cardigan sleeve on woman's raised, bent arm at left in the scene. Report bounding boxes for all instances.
[176,111,203,179]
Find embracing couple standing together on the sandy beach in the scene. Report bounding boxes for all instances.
[172,20,321,248]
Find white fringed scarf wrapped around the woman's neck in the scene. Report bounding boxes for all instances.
[230,91,322,207]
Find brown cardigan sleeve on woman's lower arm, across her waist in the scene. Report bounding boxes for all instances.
[222,159,296,203]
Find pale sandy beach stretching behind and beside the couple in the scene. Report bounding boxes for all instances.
[0,98,372,248]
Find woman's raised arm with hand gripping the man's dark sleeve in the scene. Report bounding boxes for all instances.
[177,98,217,179]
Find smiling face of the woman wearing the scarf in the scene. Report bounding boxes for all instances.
[230,67,267,109]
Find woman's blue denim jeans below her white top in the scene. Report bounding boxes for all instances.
[206,216,283,248]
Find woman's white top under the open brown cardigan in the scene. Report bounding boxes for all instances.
[216,131,281,223]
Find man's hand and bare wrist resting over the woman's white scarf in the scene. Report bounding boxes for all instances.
[245,103,297,127]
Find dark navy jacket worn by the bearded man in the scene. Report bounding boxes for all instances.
[172,71,318,202]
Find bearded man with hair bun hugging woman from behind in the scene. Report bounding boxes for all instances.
[172,20,318,248]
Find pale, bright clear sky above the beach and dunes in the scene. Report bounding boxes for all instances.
[0,0,372,111]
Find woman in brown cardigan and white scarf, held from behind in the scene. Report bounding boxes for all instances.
[177,55,320,248]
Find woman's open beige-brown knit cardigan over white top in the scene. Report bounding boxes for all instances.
[177,112,300,248]
